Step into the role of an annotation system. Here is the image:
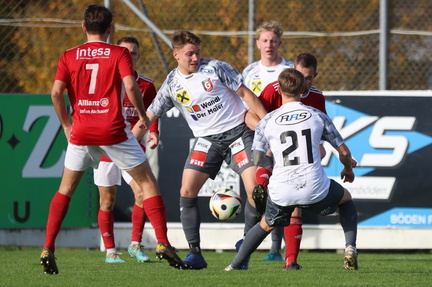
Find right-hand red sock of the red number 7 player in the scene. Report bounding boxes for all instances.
[143,198,171,246]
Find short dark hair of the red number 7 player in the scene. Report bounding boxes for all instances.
[84,5,114,35]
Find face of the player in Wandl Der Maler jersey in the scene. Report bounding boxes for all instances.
[173,44,201,75]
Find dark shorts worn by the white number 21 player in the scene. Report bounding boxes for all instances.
[264,179,344,227]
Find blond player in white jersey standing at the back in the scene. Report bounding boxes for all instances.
[242,21,294,97]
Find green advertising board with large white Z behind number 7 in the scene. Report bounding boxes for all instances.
[0,95,98,228]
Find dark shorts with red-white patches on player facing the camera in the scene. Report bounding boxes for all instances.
[184,124,254,179]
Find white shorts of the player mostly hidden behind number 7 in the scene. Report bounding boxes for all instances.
[93,161,132,187]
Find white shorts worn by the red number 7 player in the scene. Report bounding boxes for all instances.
[65,137,147,171]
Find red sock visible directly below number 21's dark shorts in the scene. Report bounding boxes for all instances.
[284,216,303,265]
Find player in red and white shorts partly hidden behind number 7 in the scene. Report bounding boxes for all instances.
[94,37,159,263]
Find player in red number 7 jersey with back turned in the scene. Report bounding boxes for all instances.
[40,5,183,274]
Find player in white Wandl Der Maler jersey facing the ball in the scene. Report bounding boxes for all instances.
[147,31,267,269]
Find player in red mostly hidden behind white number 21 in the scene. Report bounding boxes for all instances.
[246,53,327,269]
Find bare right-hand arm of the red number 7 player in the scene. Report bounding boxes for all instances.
[123,75,150,140]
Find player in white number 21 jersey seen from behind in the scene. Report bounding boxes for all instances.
[225,68,358,271]
